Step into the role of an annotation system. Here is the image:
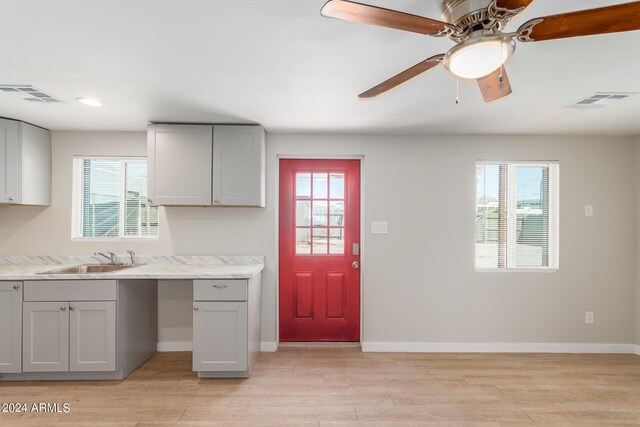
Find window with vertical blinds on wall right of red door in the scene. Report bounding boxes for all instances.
[475,162,558,269]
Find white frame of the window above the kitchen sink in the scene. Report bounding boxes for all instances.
[71,155,160,242]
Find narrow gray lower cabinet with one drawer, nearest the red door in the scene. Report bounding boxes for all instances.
[193,276,261,378]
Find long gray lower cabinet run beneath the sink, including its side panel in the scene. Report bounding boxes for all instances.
[0,280,158,381]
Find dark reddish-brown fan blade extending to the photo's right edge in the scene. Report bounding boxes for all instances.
[518,1,640,42]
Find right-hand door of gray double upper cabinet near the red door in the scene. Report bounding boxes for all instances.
[213,126,266,207]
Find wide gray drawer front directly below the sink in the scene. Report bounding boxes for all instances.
[24,280,116,301]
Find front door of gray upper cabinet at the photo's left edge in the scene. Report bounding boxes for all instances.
[0,119,20,203]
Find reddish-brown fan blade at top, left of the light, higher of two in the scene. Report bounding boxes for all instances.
[320,0,447,35]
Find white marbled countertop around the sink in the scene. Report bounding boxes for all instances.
[0,256,264,281]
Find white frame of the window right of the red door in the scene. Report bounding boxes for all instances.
[473,160,560,273]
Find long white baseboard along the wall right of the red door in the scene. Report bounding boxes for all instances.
[362,342,640,354]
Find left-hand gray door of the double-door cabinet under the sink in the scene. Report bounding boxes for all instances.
[22,302,69,372]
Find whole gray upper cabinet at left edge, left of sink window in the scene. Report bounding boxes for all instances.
[0,119,51,205]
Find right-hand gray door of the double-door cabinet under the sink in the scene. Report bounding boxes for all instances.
[69,301,116,372]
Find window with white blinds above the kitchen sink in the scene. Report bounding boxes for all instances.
[72,157,158,239]
